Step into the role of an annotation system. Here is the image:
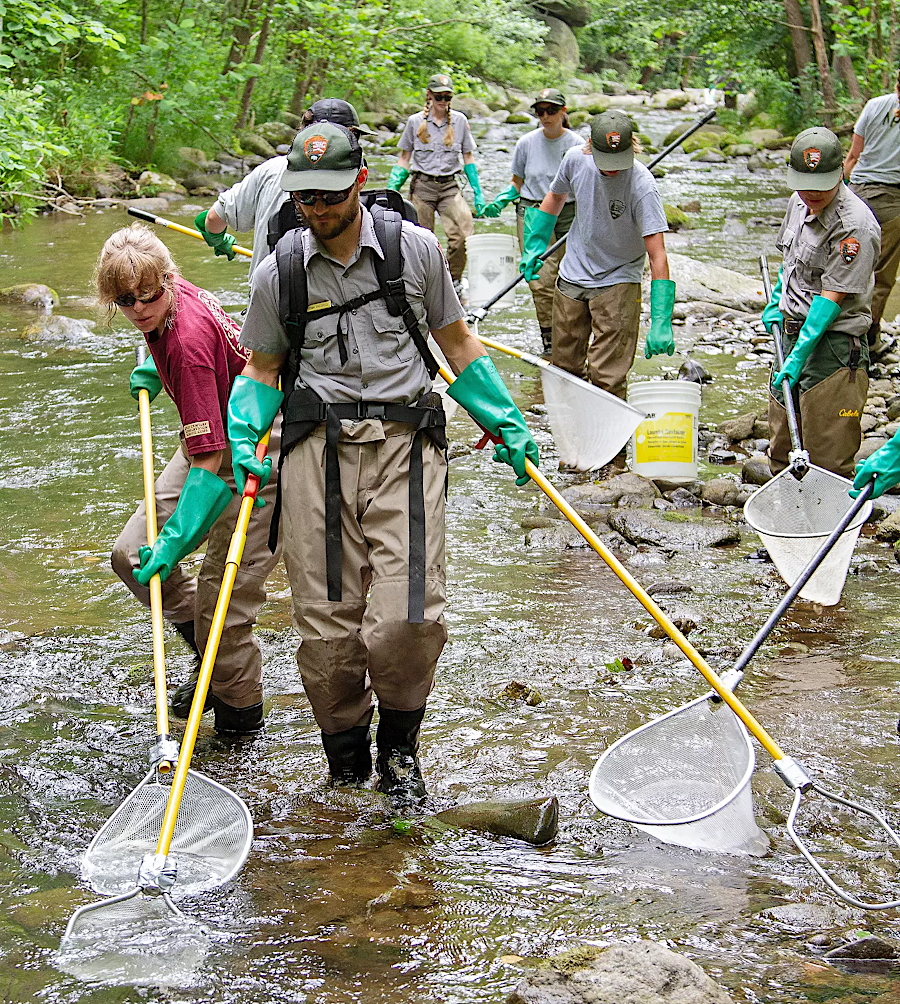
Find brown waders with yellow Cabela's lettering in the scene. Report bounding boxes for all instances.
[768,369,869,479]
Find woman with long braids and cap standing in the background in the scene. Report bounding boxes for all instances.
[388,73,484,292]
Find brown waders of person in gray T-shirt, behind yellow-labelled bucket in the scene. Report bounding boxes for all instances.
[552,282,641,401]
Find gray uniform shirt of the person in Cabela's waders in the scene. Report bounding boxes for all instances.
[775,185,881,335]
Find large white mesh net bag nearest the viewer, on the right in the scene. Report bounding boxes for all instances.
[591,696,767,853]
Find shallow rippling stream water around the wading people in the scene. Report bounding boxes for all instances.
[0,112,900,1004]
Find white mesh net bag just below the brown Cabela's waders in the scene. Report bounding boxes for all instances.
[743,465,872,606]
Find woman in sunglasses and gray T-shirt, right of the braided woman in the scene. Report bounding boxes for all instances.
[482,87,584,355]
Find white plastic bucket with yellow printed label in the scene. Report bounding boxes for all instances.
[628,380,700,480]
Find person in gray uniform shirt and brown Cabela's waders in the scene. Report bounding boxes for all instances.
[762,127,880,478]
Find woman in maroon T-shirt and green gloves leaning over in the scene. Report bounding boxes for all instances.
[100,223,280,735]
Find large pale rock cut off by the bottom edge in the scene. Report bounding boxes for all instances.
[506,941,733,1004]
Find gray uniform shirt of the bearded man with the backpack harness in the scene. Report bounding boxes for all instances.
[240,208,465,405]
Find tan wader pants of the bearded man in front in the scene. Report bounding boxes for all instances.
[281,420,447,733]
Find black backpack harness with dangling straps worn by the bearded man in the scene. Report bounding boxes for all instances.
[269,203,447,623]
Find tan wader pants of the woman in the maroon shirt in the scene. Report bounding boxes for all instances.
[113,419,281,708]
